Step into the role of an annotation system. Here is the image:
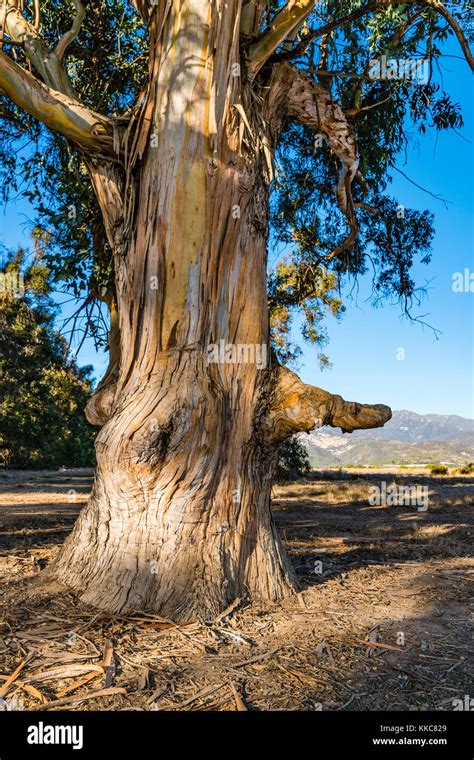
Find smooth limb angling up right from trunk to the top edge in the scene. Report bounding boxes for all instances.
[249,0,317,75]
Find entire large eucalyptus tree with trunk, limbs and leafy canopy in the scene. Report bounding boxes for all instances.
[0,0,473,619]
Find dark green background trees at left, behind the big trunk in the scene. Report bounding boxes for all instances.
[0,246,95,467]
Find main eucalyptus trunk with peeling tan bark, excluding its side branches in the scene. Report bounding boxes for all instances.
[52,0,295,620]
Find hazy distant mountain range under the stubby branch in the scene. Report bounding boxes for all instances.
[301,410,474,467]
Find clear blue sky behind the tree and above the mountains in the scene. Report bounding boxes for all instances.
[0,45,474,417]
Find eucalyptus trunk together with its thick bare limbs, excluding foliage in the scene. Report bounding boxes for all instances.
[0,0,390,621]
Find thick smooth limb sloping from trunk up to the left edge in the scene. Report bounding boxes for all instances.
[0,51,115,156]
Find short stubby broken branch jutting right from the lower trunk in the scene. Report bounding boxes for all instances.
[265,367,392,443]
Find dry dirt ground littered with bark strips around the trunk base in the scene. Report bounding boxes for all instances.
[0,469,474,711]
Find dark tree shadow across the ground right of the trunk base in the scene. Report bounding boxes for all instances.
[273,473,474,589]
